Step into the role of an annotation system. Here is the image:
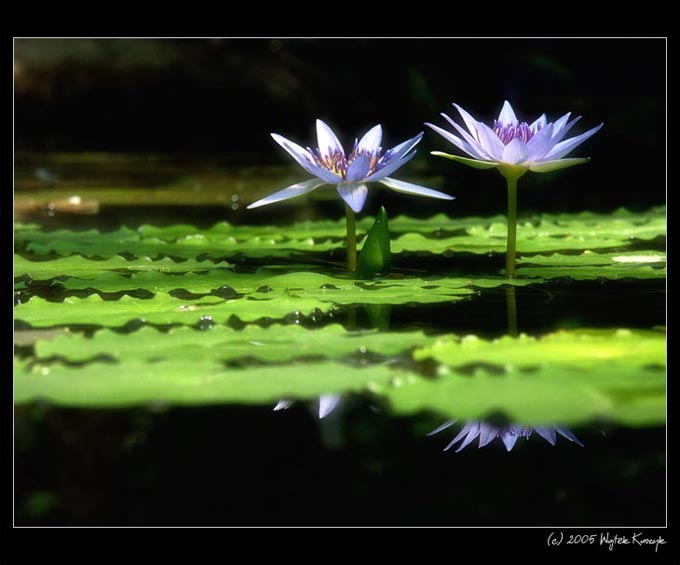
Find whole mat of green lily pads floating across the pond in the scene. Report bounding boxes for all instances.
[14,207,666,426]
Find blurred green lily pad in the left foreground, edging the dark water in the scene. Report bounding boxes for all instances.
[14,359,393,408]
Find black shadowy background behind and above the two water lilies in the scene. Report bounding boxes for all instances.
[14,39,666,214]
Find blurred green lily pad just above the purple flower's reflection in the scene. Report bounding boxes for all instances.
[384,362,666,426]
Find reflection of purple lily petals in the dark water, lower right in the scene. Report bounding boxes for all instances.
[427,420,583,453]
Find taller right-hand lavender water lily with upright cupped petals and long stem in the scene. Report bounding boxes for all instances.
[425,100,604,278]
